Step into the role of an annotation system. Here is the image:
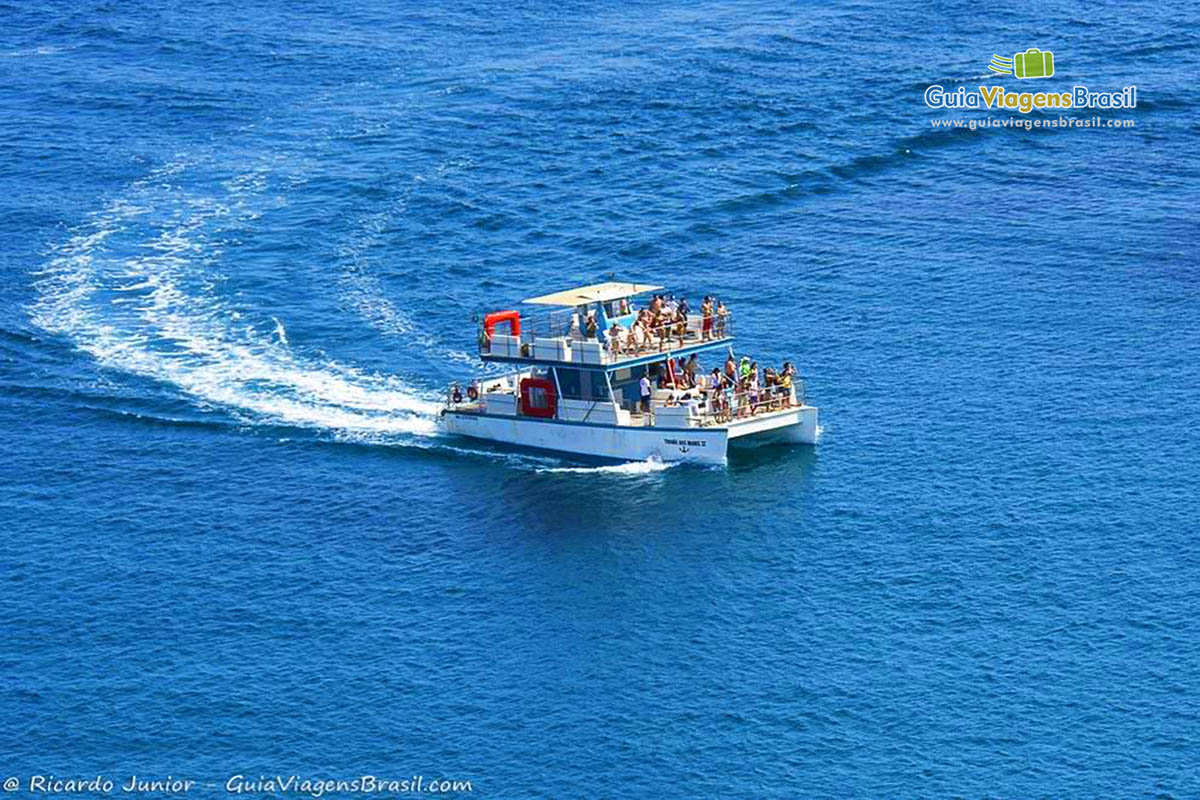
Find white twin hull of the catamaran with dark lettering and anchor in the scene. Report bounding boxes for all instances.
[443,405,817,464]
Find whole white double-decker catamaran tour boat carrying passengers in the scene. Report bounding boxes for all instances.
[440,282,818,464]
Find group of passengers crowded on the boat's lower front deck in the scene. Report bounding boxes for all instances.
[642,353,796,420]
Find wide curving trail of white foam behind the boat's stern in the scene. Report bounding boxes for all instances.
[31,163,439,435]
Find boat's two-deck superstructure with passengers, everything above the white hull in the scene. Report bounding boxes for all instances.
[448,282,803,428]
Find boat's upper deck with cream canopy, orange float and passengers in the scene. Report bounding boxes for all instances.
[479,283,733,371]
